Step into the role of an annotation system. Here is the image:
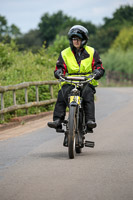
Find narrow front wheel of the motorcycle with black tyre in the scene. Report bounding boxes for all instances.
[68,106,76,159]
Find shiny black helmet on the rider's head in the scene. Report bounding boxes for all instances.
[68,25,88,46]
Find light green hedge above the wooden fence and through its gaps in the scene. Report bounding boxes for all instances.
[0,42,58,120]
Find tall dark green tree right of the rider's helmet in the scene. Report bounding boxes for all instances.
[90,5,133,53]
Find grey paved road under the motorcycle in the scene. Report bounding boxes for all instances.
[0,88,133,200]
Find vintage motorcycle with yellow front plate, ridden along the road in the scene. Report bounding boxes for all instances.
[56,74,95,159]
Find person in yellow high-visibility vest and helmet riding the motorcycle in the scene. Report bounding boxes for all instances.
[48,25,105,136]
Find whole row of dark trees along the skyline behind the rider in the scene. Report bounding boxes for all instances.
[0,5,133,53]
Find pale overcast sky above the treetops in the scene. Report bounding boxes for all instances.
[0,0,133,33]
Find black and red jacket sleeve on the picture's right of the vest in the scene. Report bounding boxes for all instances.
[92,50,105,77]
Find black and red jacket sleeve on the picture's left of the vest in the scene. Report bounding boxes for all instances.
[54,53,67,75]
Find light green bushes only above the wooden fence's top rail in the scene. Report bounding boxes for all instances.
[0,43,57,85]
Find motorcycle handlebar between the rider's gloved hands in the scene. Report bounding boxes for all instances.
[59,74,95,84]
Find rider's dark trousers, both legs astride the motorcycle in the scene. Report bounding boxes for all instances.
[53,83,96,122]
